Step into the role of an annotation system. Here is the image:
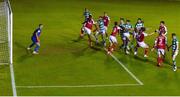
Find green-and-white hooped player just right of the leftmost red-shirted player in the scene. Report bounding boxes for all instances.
[95,16,106,46]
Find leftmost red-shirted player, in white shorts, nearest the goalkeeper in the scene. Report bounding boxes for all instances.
[82,15,95,47]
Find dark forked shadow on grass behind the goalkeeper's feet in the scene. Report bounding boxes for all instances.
[14,42,32,62]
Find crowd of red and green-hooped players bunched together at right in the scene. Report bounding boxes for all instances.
[80,8,179,71]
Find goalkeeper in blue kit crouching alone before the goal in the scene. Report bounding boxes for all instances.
[27,24,43,54]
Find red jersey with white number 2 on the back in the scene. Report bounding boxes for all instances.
[155,36,167,49]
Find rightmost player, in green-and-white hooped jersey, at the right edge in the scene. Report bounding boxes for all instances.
[169,33,179,71]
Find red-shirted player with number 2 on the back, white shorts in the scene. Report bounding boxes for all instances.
[152,33,168,66]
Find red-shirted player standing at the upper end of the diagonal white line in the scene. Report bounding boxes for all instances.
[107,22,120,54]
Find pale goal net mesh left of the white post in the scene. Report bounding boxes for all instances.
[0,2,10,64]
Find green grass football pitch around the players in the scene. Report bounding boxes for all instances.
[0,0,180,96]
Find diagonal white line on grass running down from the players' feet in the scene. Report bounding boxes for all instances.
[104,48,144,85]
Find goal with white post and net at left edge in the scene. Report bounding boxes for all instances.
[0,0,12,65]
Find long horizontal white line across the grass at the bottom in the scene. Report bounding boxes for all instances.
[17,84,140,88]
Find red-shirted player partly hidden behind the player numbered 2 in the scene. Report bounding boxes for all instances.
[155,21,167,36]
